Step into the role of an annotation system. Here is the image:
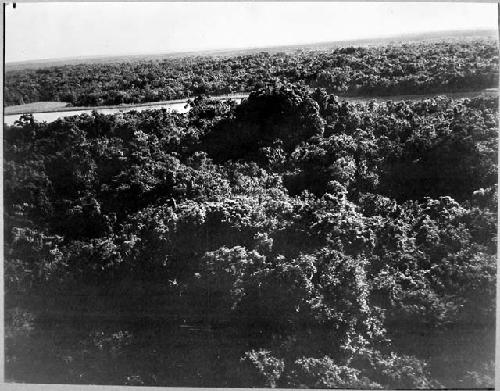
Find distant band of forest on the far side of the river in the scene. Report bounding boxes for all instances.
[4,38,498,106]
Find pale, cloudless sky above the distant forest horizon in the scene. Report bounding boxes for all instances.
[5,2,498,62]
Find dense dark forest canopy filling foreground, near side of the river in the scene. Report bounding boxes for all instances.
[4,81,498,388]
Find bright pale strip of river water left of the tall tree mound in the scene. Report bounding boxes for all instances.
[3,98,242,125]
